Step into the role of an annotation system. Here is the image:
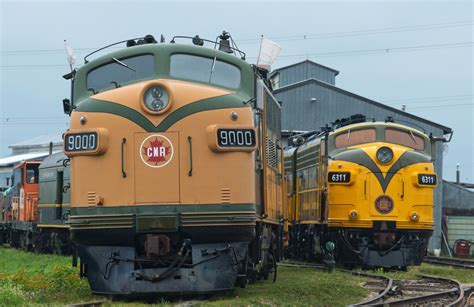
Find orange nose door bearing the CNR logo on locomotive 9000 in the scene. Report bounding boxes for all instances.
[134,132,179,204]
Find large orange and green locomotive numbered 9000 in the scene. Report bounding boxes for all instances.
[63,33,284,294]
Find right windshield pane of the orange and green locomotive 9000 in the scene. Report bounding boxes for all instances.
[170,54,241,88]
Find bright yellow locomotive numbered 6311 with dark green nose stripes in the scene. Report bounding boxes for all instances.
[285,117,437,268]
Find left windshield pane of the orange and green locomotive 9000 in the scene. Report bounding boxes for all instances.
[87,54,155,92]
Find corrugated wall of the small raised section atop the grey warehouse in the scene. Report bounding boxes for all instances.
[279,61,336,87]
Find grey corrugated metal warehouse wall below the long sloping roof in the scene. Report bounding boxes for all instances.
[275,80,443,250]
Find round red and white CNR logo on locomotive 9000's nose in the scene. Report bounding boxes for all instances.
[140,134,174,168]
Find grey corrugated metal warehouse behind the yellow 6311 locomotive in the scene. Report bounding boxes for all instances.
[270,60,452,251]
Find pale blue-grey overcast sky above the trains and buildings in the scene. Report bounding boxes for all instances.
[0,0,474,182]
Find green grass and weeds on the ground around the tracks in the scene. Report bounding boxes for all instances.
[0,247,474,306]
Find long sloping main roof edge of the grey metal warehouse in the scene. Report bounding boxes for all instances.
[273,78,453,134]
